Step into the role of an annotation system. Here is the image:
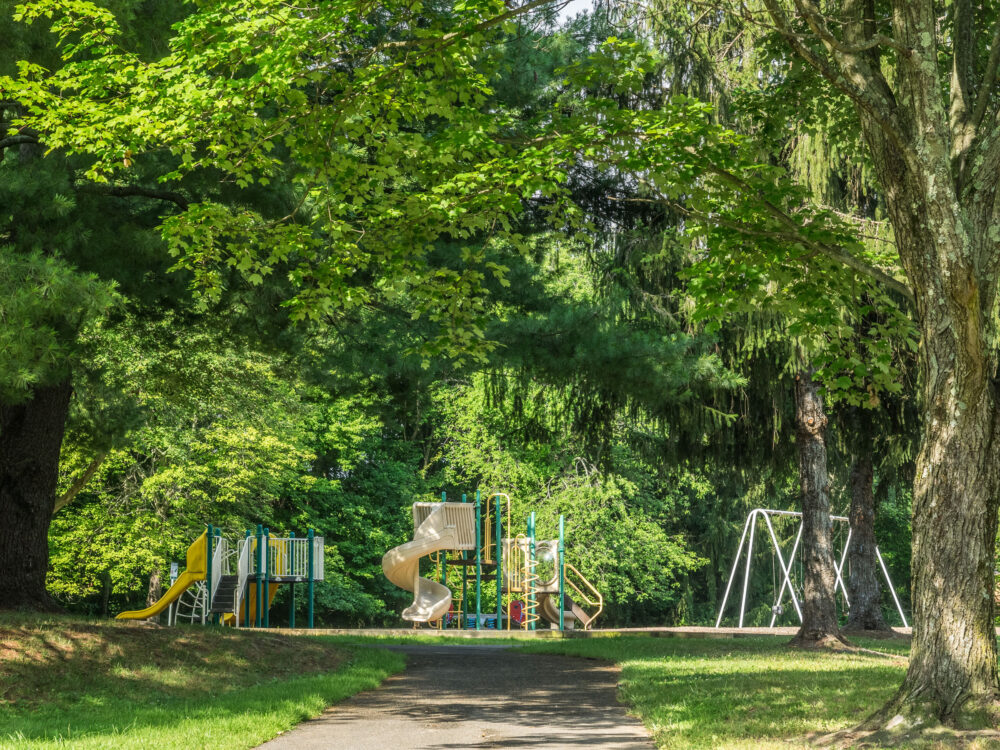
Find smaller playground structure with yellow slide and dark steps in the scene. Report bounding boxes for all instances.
[116,526,324,628]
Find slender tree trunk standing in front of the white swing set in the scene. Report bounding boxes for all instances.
[792,371,842,646]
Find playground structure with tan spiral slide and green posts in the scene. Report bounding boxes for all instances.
[382,492,604,630]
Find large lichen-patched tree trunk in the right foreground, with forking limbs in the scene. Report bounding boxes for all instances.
[765,0,1000,731]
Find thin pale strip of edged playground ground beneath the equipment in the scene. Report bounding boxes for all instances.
[244,626,911,640]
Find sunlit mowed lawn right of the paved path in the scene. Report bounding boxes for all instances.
[523,637,908,750]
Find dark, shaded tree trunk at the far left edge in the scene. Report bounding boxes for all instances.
[0,379,72,610]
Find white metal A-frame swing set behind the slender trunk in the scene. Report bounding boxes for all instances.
[715,508,909,628]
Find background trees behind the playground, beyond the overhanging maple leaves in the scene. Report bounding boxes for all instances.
[0,3,913,625]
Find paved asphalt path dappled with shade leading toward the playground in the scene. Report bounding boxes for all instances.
[262,644,654,750]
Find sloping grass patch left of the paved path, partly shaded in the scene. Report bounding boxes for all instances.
[0,615,404,750]
